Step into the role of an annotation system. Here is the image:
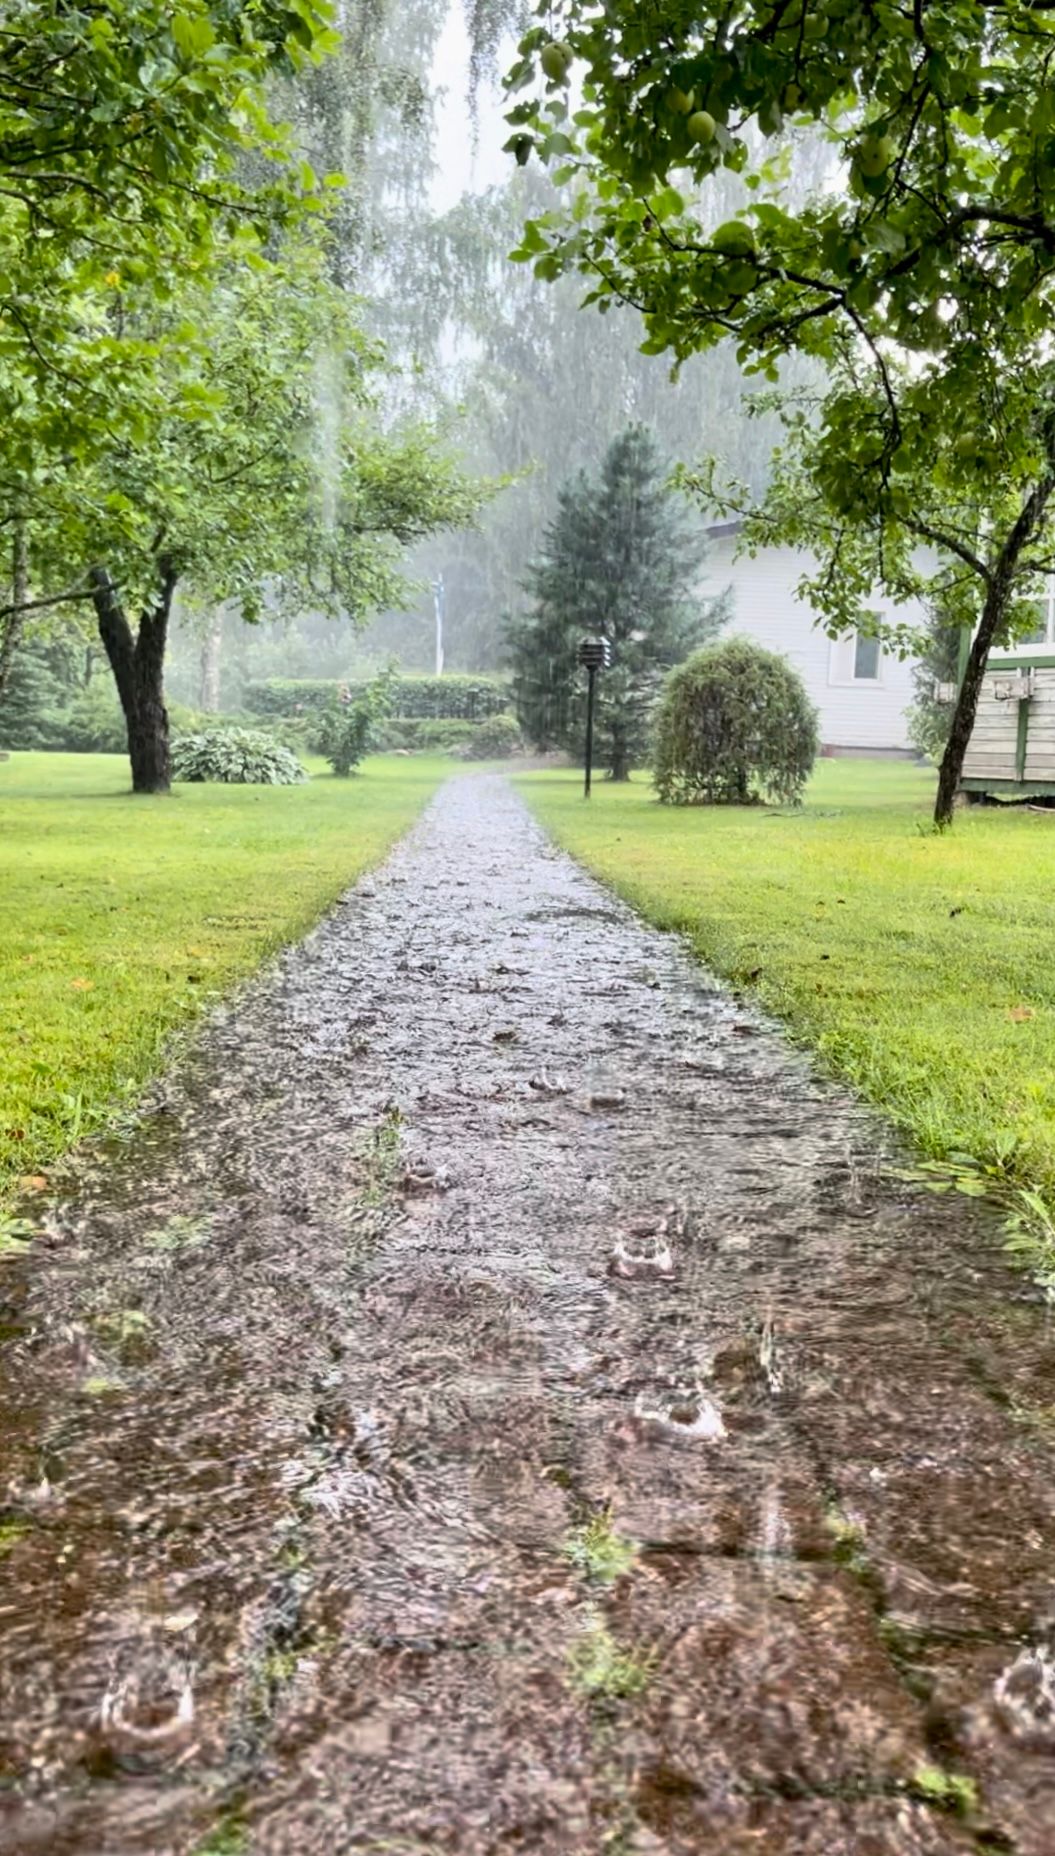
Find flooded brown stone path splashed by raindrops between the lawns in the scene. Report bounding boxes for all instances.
[0,776,1055,1856]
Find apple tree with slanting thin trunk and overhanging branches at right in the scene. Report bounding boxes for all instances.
[509,0,1055,818]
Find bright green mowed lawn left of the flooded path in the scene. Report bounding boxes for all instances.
[0,754,451,1201]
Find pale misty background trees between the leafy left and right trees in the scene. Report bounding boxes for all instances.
[169,0,823,707]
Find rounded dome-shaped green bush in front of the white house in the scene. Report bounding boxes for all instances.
[652,638,817,806]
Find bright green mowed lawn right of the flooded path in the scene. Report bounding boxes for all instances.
[520,761,1055,1199]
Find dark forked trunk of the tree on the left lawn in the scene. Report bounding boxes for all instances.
[91,561,176,793]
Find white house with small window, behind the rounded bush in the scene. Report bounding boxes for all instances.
[702,522,925,755]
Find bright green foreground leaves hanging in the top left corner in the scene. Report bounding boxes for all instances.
[0,0,334,473]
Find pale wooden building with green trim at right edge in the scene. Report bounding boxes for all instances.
[962,579,1055,798]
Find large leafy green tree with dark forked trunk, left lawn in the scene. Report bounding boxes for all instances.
[0,0,483,791]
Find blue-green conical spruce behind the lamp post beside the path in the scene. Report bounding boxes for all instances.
[509,425,724,780]
